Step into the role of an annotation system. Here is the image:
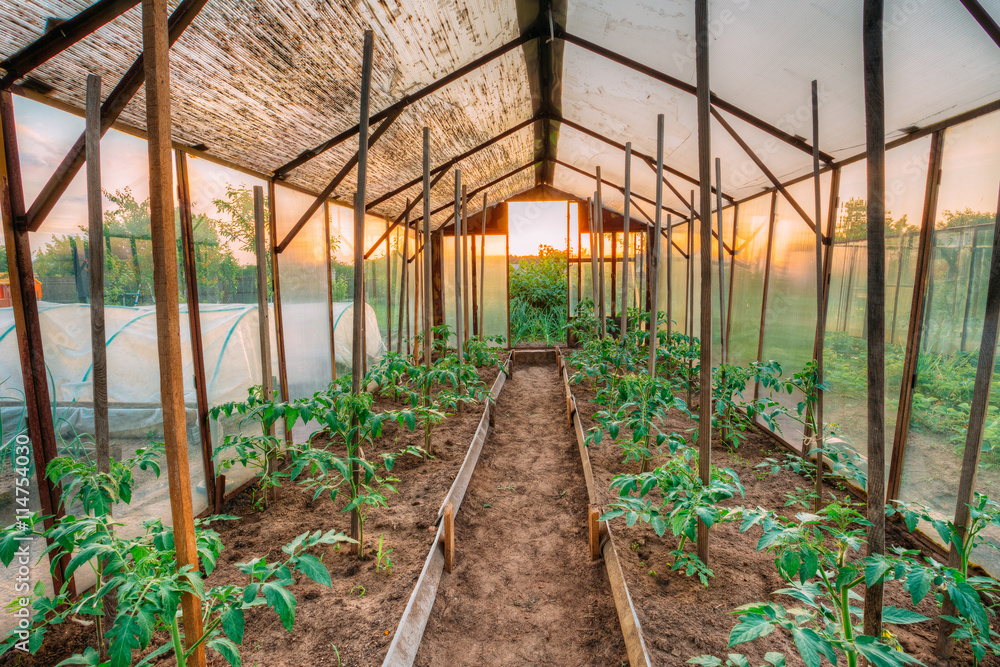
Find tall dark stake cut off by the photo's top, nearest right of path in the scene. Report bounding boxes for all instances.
[695,0,722,565]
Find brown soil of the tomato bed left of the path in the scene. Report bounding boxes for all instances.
[0,368,497,667]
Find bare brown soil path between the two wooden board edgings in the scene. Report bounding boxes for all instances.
[416,364,627,667]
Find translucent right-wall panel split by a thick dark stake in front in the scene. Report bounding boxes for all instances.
[823,138,930,470]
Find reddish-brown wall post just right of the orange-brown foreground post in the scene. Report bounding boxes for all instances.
[176,149,215,507]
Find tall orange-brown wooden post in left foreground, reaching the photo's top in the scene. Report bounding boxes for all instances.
[142,0,205,667]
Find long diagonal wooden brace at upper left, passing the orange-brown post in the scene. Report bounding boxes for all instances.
[27,0,208,232]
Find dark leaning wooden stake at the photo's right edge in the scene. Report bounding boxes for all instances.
[935,183,1000,661]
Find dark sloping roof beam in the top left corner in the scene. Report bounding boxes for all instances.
[0,0,139,90]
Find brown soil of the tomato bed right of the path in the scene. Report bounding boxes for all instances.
[572,374,1000,665]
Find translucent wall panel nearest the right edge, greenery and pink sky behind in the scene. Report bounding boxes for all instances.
[900,108,1000,573]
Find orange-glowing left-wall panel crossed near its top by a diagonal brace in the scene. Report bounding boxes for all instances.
[274,185,336,398]
